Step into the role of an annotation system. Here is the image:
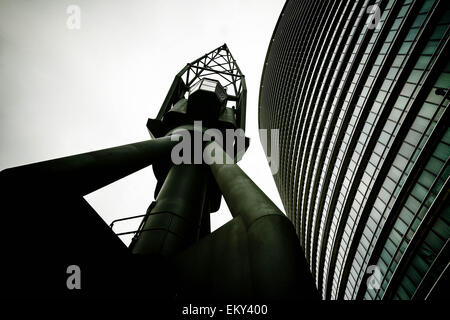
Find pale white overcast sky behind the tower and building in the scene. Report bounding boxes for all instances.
[0,0,284,243]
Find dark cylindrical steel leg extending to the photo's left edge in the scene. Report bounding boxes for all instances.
[0,137,178,195]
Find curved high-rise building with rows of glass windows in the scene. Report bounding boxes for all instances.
[259,0,450,299]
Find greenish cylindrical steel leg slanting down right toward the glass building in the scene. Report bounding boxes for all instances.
[204,144,320,299]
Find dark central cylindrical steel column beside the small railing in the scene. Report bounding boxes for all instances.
[132,164,209,256]
